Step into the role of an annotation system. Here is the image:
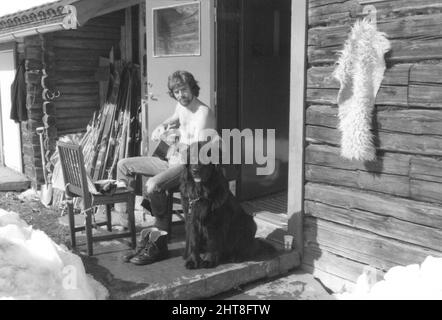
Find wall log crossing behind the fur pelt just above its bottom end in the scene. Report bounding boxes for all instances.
[306,125,442,156]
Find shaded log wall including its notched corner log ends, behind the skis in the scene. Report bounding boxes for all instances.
[17,11,124,188]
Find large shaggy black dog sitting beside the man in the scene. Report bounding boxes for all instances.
[180,146,257,269]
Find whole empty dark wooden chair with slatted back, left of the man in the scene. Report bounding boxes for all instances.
[57,142,136,256]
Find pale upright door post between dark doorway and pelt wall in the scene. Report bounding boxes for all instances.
[287,0,307,258]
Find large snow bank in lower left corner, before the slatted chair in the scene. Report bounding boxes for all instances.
[0,209,108,300]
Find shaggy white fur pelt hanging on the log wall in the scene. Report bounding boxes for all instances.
[333,19,390,161]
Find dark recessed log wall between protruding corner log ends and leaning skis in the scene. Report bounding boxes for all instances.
[50,11,124,135]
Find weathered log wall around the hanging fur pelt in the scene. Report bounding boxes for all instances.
[303,0,442,290]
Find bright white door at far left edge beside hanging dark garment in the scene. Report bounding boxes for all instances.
[0,49,23,173]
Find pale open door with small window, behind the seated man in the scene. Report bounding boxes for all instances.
[145,0,215,150]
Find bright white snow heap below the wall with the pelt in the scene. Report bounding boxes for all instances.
[335,256,442,300]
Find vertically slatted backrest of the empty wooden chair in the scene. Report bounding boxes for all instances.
[57,142,91,204]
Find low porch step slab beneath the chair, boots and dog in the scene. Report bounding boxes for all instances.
[73,225,300,300]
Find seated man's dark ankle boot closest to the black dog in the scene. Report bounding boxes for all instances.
[130,230,169,266]
